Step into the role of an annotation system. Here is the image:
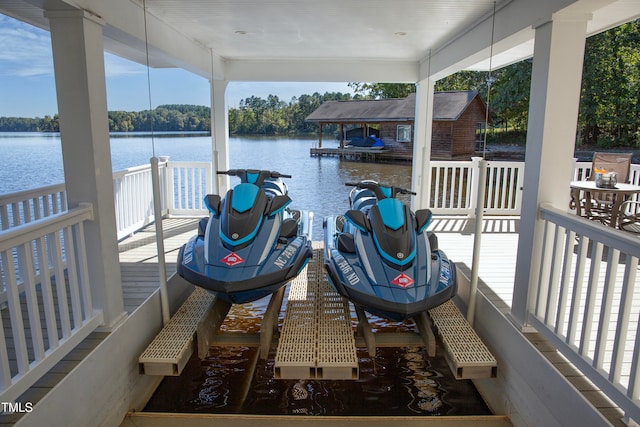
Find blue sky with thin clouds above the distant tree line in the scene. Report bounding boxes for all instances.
[0,14,353,117]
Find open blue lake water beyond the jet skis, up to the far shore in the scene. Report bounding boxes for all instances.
[0,132,411,240]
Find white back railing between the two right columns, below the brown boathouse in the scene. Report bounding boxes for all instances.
[429,158,524,216]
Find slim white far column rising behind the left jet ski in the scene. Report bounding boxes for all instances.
[211,80,229,195]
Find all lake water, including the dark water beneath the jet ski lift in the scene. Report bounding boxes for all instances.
[0,133,489,415]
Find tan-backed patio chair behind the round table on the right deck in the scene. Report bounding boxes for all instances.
[579,152,633,224]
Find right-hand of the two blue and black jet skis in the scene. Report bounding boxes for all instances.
[323,181,457,321]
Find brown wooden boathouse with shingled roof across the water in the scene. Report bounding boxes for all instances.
[306,91,487,160]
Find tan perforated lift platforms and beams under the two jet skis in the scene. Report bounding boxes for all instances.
[139,242,497,380]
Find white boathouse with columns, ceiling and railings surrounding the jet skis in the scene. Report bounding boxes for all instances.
[0,0,640,427]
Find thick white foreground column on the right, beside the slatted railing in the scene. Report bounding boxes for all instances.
[511,15,590,327]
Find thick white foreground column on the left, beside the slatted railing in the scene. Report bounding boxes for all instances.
[46,10,126,328]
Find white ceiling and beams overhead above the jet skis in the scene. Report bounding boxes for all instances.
[0,0,640,81]
